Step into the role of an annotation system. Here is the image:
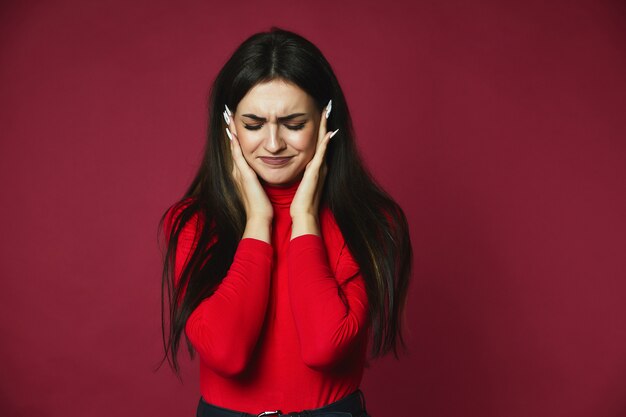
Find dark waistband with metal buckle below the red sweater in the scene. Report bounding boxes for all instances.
[196,389,367,417]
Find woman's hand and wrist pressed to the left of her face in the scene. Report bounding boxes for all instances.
[225,107,274,223]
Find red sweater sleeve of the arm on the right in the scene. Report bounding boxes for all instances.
[288,234,368,368]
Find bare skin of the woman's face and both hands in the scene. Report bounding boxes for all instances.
[222,80,332,243]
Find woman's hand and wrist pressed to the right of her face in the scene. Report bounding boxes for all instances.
[289,102,339,239]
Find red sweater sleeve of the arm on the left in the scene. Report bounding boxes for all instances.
[168,210,273,377]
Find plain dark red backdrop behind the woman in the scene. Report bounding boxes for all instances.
[0,0,626,417]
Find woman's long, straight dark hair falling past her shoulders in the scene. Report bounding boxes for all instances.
[159,27,413,374]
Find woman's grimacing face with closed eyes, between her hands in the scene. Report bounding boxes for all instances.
[233,80,321,186]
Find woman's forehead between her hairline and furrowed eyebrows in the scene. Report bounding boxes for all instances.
[237,80,315,116]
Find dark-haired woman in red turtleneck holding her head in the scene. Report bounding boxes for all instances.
[160,28,412,417]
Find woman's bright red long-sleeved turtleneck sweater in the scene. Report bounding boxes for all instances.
[168,179,369,414]
